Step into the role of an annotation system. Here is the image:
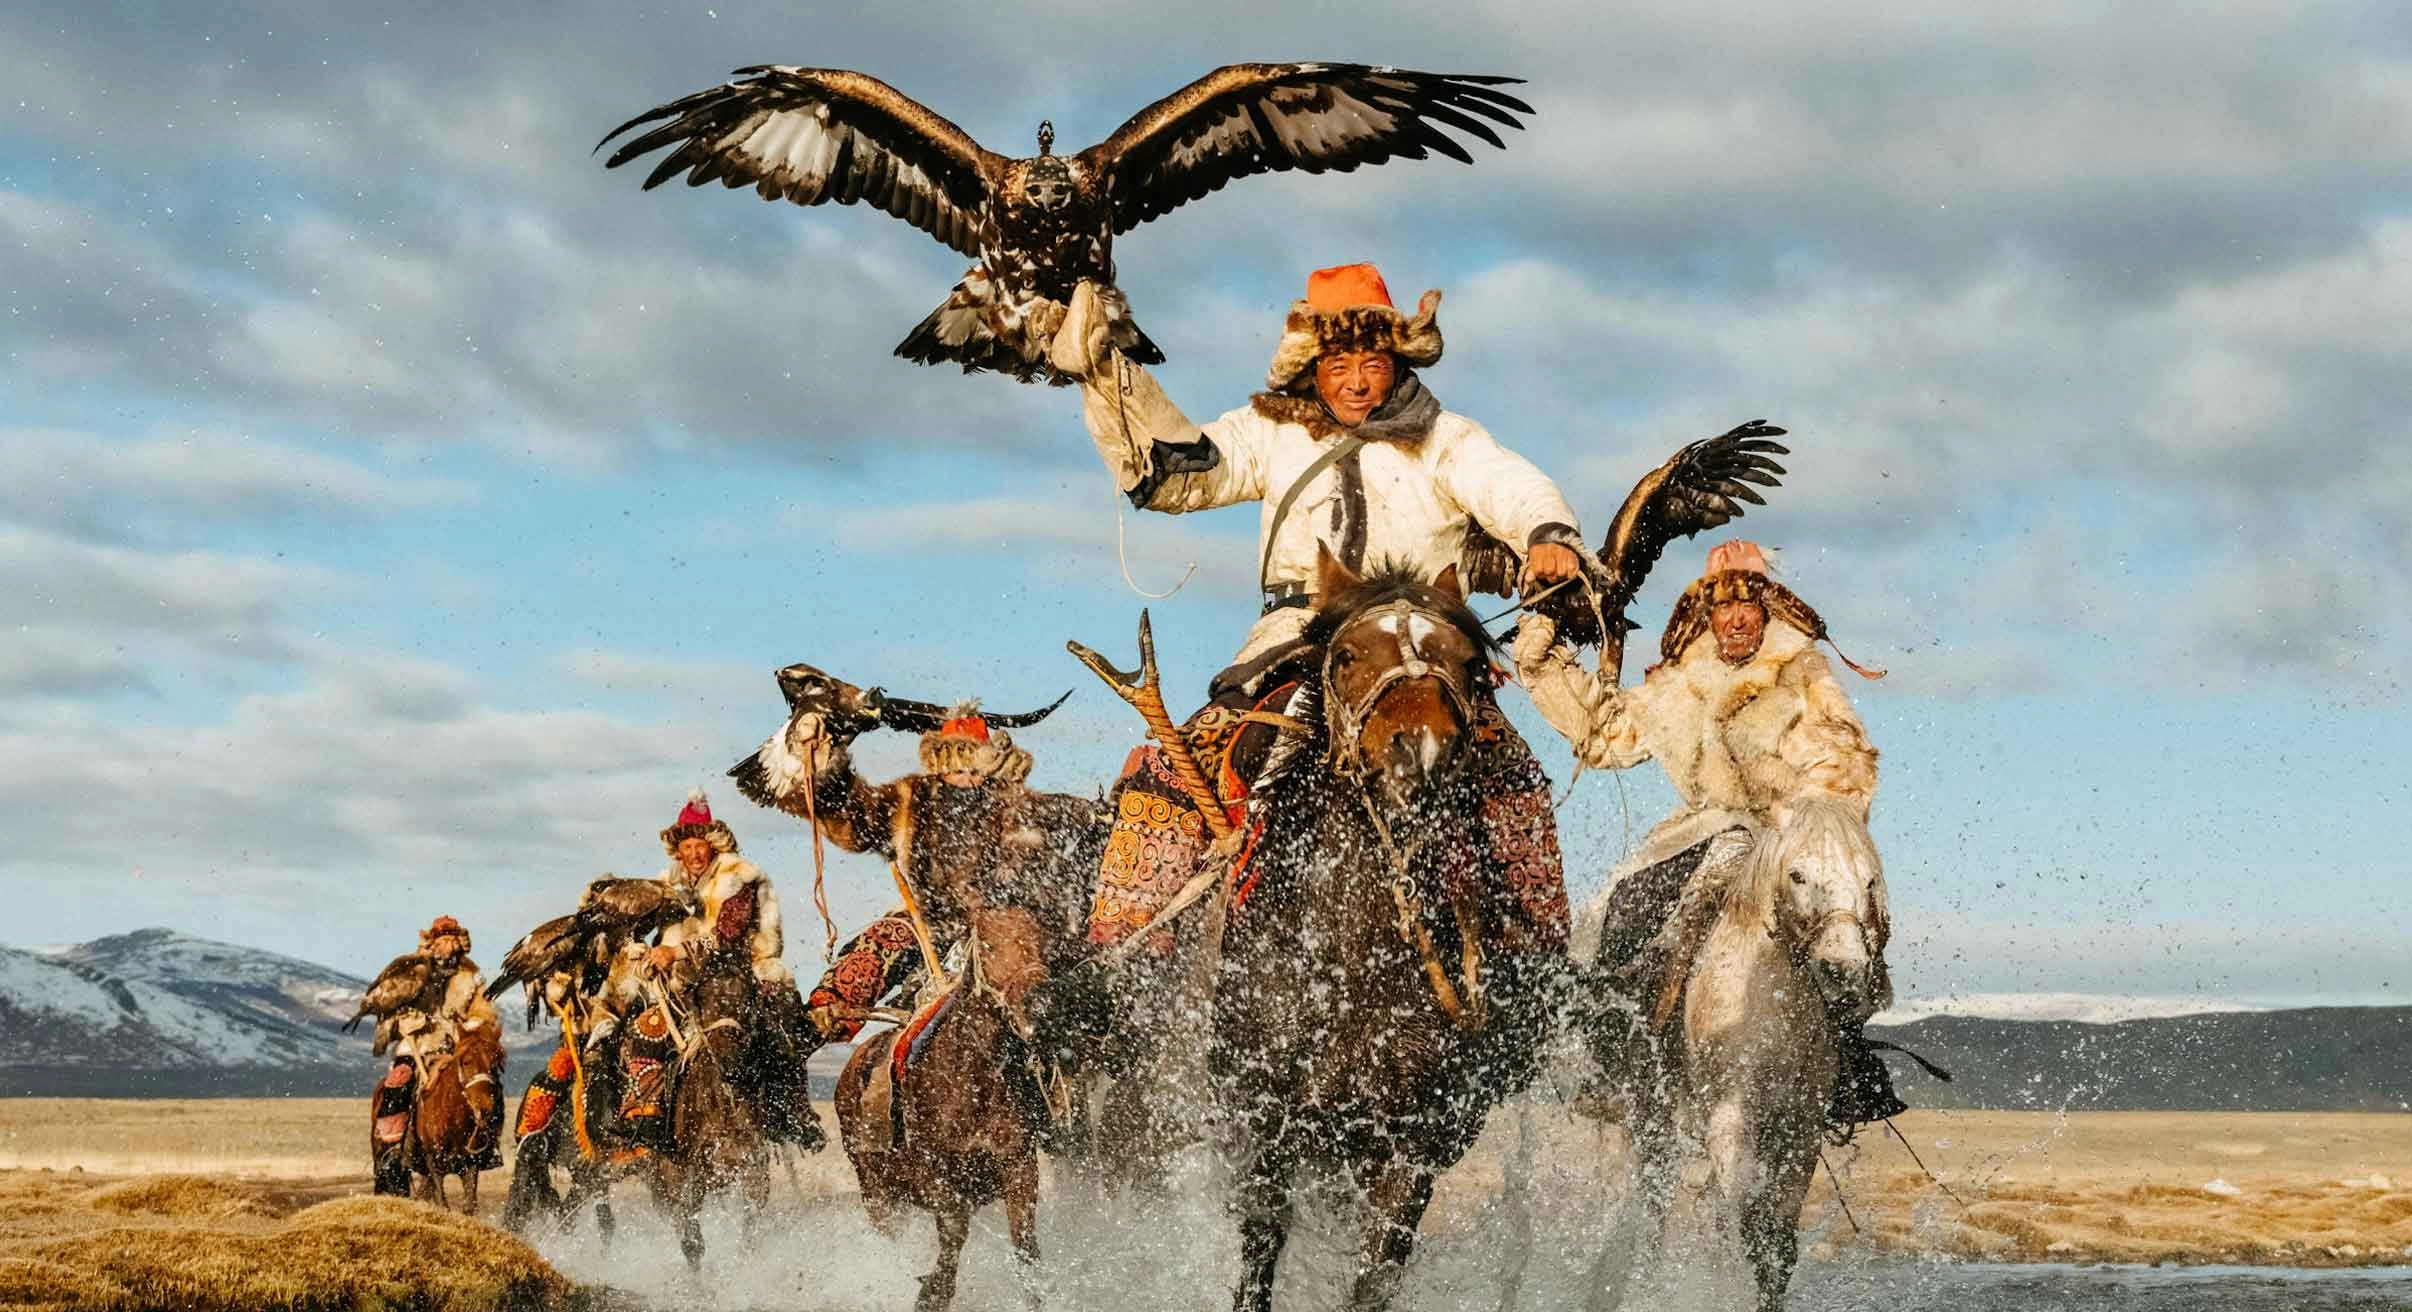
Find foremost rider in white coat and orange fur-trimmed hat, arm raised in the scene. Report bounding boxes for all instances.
[1052,265,1582,957]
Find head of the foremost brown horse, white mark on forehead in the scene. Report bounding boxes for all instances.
[1305,550,1491,813]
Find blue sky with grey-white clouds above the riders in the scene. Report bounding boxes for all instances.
[0,2,2412,1001]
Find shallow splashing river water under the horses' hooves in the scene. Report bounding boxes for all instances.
[538,1182,2412,1312]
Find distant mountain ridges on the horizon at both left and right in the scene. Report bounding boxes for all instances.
[0,929,2412,1112]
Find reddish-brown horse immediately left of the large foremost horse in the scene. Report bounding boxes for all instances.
[837,902,1049,1312]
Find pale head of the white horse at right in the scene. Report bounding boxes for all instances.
[1761,796,1893,1023]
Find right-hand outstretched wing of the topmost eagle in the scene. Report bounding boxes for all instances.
[1081,63,1532,232]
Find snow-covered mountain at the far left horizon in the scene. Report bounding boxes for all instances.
[0,929,550,1097]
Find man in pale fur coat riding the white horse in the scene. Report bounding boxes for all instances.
[1517,538,1905,1124]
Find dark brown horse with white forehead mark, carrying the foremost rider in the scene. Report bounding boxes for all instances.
[1211,557,1563,1312]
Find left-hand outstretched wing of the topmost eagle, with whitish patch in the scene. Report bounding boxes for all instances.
[612,65,1006,256]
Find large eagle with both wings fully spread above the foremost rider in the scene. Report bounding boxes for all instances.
[612,63,1532,383]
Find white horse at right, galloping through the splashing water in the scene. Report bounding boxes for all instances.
[1594,798,1893,1312]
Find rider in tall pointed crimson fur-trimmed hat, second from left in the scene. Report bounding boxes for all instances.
[608,789,825,1150]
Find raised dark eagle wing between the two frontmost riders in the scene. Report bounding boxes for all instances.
[1561,420,1792,644]
